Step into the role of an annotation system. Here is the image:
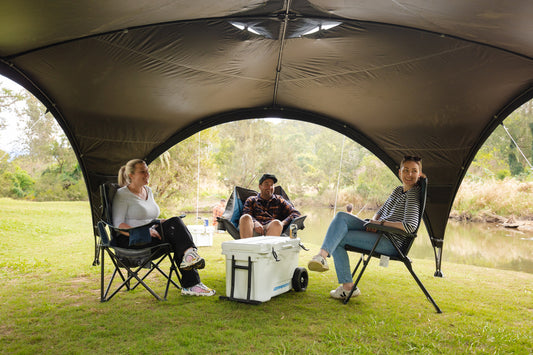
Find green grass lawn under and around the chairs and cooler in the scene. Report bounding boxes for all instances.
[0,199,533,354]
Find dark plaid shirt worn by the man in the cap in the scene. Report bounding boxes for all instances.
[242,194,301,225]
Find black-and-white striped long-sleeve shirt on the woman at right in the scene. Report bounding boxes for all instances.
[377,186,420,233]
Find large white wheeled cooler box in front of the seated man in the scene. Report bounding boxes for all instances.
[222,236,307,303]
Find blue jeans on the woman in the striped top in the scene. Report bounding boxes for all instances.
[322,212,388,283]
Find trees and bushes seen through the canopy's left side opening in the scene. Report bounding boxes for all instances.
[0,85,87,201]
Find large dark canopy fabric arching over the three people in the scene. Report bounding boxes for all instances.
[0,0,533,272]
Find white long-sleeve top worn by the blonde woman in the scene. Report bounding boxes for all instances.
[112,186,161,227]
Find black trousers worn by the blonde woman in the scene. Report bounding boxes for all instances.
[119,217,200,288]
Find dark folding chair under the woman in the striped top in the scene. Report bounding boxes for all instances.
[344,178,442,313]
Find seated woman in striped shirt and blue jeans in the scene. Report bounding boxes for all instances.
[308,156,425,299]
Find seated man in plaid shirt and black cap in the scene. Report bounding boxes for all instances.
[239,174,300,238]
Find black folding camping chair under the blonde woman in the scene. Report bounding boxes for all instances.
[94,183,181,302]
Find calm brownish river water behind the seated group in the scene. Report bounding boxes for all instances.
[185,208,533,274]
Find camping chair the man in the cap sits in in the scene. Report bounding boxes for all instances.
[217,186,307,239]
